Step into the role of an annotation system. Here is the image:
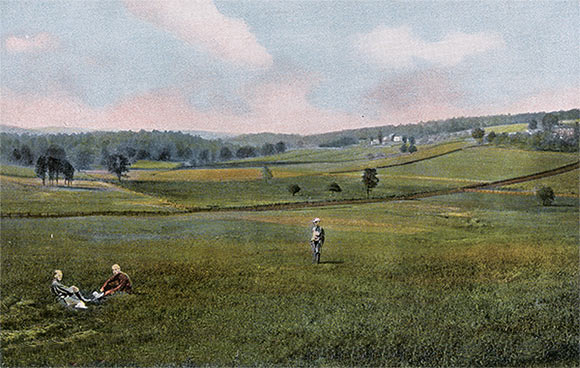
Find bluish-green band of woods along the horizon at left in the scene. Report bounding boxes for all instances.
[0,130,286,170]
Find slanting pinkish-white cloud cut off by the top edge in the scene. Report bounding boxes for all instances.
[124,0,272,67]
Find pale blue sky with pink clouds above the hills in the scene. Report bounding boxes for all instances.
[0,0,580,134]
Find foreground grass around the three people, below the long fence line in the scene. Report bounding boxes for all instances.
[0,194,580,366]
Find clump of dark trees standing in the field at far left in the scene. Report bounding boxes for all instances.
[34,146,75,185]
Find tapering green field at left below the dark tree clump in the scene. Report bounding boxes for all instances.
[0,177,175,215]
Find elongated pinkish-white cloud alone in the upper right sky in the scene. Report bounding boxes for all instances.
[355,26,505,68]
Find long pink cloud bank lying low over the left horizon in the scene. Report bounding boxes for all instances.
[0,76,366,134]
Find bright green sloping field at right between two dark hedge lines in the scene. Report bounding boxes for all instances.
[378,146,578,181]
